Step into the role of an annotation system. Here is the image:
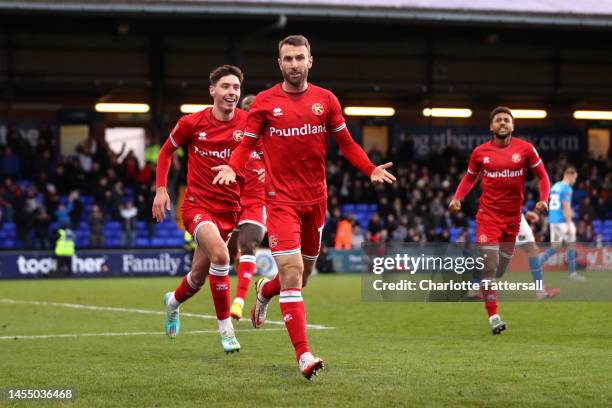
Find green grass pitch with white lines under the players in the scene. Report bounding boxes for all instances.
[0,275,612,407]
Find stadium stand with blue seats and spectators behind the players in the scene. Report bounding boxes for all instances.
[0,127,612,249]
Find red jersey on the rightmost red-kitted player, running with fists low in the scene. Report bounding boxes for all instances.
[468,137,542,219]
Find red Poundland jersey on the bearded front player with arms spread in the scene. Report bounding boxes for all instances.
[244,84,346,205]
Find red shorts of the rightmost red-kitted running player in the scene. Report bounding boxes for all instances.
[476,211,521,255]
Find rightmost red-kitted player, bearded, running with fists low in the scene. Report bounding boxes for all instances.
[449,106,550,334]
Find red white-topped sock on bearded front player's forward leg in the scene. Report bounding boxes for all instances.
[279,288,310,360]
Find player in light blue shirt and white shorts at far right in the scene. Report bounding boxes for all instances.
[540,167,586,282]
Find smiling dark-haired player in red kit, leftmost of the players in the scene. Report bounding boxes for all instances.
[153,65,247,353]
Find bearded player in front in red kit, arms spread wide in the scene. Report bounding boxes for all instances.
[213,35,395,379]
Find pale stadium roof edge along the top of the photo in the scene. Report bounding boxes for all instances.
[0,0,612,27]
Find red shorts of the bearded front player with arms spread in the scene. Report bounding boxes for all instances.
[266,201,327,260]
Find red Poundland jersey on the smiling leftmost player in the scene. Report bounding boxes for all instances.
[170,108,247,211]
